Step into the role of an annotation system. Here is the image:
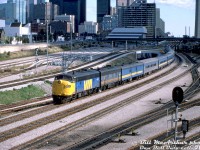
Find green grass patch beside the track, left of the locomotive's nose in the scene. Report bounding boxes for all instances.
[0,85,46,105]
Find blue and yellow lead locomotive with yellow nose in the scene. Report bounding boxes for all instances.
[52,70,100,104]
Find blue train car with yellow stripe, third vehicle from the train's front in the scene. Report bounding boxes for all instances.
[122,63,144,82]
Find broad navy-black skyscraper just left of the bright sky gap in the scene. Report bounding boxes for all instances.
[50,0,86,32]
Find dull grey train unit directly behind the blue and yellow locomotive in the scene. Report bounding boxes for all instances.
[99,67,121,90]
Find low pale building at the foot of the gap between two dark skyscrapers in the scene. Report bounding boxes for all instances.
[78,21,98,35]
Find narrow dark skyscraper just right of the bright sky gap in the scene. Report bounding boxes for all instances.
[97,0,110,23]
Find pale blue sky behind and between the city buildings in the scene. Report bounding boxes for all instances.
[0,0,195,37]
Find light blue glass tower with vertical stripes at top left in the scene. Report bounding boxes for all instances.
[7,0,26,24]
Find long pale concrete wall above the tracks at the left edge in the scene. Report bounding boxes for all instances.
[0,43,47,53]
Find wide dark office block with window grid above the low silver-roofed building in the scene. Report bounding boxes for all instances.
[118,0,156,38]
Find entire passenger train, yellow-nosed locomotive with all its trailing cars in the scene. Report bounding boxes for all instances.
[52,50,174,104]
